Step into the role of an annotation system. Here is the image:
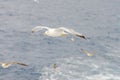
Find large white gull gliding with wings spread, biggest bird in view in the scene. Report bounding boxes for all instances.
[32,26,86,39]
